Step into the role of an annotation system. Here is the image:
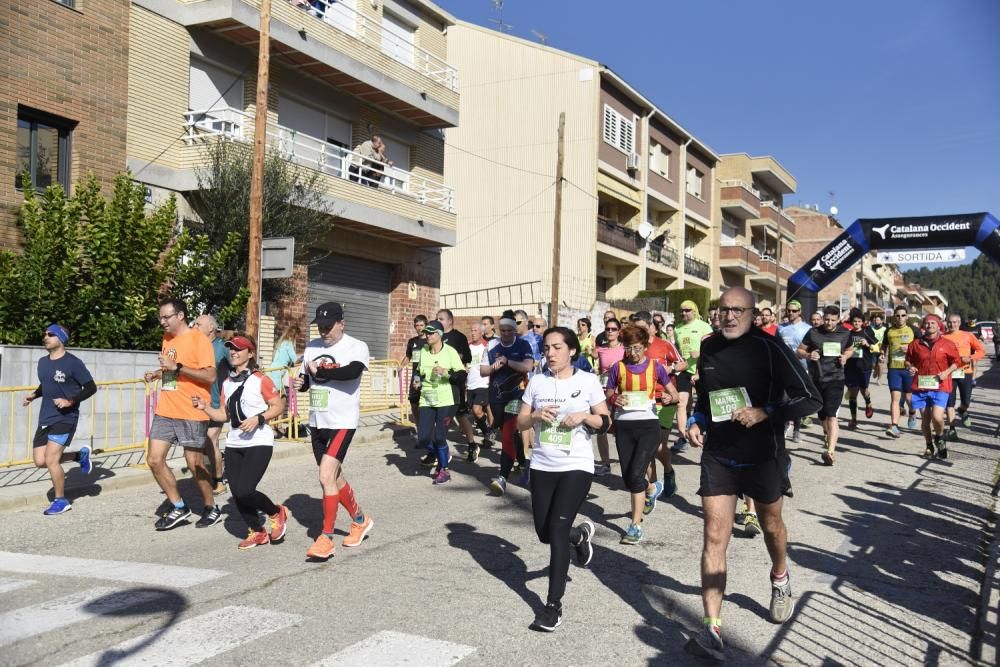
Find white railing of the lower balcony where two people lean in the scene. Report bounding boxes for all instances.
[184,107,454,213]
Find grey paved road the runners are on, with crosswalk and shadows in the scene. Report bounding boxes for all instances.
[0,358,1000,667]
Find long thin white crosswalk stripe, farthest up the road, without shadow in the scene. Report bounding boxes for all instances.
[0,551,229,588]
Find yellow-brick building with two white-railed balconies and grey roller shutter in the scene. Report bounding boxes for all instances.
[127,0,459,358]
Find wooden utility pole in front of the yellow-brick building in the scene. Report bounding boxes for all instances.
[246,0,271,338]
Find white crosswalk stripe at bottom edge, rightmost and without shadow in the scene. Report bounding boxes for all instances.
[311,631,476,667]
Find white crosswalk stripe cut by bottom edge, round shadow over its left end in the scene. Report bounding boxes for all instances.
[63,606,302,667]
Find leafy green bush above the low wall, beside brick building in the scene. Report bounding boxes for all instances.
[0,174,247,349]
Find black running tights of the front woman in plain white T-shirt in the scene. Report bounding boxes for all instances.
[530,470,594,604]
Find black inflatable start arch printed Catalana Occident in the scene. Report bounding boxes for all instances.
[787,213,1000,314]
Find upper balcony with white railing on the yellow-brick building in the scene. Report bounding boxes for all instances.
[168,0,458,127]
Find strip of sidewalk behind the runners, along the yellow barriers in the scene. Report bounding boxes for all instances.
[0,414,411,512]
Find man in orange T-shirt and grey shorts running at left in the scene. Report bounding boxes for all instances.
[145,299,222,530]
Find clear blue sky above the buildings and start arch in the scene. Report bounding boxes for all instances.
[437,0,1000,268]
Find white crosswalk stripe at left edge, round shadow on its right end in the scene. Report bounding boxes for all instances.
[0,587,164,647]
